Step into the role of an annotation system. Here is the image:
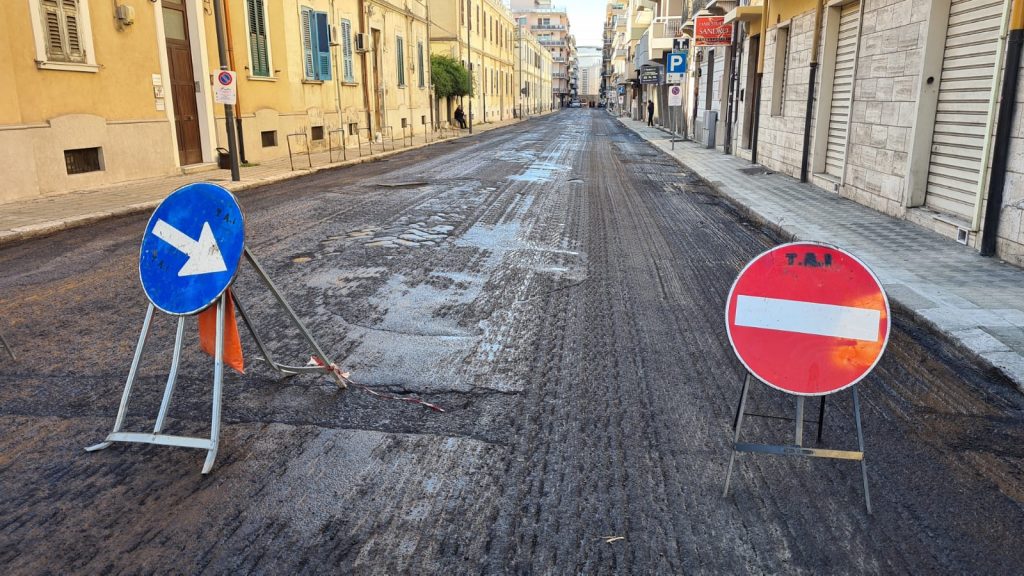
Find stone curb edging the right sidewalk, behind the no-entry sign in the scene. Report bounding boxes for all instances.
[615,117,1024,394]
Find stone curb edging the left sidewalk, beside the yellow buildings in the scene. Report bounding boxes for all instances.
[0,116,536,248]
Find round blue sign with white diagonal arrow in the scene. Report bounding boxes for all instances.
[138,182,245,316]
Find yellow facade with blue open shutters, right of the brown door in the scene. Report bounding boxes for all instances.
[206,0,430,162]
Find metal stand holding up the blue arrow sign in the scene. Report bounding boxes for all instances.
[89,248,347,474]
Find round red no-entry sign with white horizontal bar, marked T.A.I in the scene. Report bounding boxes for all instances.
[725,242,890,396]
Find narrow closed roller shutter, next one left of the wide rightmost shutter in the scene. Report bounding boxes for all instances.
[825,2,860,177]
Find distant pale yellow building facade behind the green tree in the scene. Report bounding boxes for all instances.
[430,0,518,122]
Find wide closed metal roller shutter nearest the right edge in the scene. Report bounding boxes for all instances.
[925,0,1004,221]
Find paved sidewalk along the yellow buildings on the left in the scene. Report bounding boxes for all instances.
[0,120,519,246]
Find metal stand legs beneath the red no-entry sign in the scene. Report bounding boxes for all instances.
[722,372,871,513]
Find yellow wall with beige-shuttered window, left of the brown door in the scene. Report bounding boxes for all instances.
[0,0,177,202]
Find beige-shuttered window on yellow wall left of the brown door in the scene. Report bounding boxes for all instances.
[29,0,99,72]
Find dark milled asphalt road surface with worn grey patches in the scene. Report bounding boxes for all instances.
[0,110,1024,574]
